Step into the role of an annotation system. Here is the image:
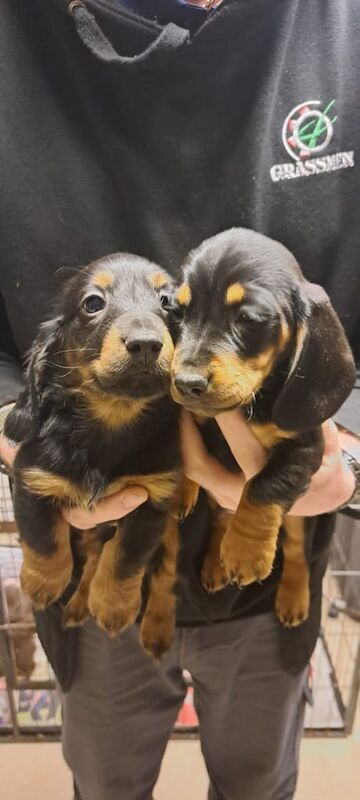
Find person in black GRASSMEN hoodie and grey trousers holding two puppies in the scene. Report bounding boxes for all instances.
[0,0,360,800]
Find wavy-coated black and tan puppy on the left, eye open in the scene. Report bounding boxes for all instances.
[6,254,184,655]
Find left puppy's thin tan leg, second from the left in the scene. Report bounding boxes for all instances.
[63,528,103,628]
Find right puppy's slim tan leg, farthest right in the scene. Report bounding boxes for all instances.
[276,516,310,628]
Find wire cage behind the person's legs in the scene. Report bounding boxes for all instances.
[0,473,360,742]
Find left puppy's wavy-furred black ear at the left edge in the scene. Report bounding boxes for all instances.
[4,316,64,443]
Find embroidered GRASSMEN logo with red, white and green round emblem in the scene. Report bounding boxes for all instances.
[270,100,355,182]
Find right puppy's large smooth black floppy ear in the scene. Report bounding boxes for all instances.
[272,282,355,432]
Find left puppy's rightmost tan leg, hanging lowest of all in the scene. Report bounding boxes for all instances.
[140,514,179,661]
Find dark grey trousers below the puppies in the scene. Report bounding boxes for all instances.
[62,614,305,800]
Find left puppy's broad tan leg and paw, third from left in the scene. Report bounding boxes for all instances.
[89,527,144,636]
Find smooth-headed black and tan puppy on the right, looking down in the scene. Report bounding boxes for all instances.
[172,228,355,625]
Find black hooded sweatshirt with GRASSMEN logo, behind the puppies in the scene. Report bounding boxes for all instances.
[0,0,360,685]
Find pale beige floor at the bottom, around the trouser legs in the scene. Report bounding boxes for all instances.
[0,730,360,800]
